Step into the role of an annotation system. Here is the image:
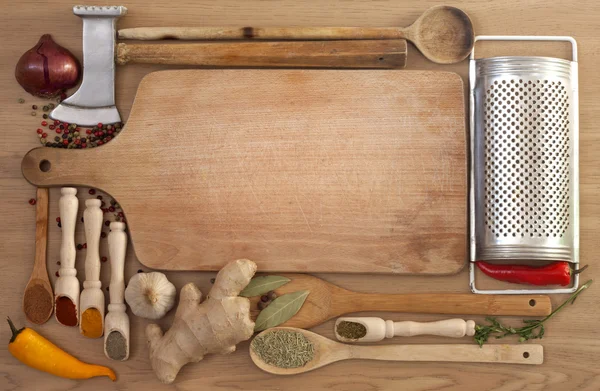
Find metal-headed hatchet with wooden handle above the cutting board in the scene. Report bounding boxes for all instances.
[50,5,406,126]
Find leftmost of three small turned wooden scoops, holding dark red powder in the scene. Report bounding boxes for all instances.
[54,187,79,327]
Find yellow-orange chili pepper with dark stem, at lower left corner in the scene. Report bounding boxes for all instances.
[8,318,117,381]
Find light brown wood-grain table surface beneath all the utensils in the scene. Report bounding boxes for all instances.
[0,0,600,391]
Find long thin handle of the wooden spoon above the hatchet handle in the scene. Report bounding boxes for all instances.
[119,27,406,40]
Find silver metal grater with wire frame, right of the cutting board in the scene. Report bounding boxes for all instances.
[469,36,579,294]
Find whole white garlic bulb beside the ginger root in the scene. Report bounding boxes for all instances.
[125,272,177,319]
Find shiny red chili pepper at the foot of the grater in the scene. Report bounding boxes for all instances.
[476,261,587,286]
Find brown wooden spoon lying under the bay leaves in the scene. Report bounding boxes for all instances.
[250,274,552,329]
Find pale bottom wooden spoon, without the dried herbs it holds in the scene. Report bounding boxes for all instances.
[250,327,544,375]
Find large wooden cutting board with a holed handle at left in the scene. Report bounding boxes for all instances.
[22,70,467,274]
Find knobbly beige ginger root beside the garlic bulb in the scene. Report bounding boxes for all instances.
[146,259,256,384]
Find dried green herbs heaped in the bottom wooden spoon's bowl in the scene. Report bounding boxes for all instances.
[250,330,315,368]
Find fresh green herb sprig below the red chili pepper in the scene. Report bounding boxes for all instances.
[474,280,593,346]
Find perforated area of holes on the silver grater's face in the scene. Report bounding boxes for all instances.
[483,78,572,238]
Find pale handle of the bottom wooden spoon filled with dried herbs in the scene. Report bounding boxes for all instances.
[350,344,544,365]
